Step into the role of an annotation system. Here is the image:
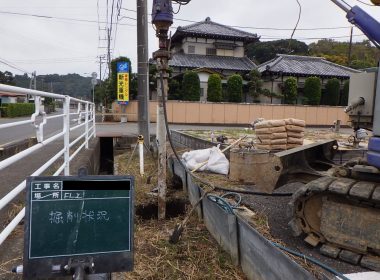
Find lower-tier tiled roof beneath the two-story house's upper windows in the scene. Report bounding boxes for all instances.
[169,53,256,71]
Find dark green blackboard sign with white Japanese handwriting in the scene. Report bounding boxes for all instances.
[23,176,134,279]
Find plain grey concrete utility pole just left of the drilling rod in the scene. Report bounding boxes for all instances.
[136,0,150,147]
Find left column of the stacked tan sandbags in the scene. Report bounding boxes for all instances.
[255,120,288,150]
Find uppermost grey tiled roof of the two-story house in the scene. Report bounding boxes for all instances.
[172,18,259,42]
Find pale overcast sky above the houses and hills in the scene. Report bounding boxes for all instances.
[0,0,380,76]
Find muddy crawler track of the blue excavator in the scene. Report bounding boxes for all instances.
[289,177,380,271]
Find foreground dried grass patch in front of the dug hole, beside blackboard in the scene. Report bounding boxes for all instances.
[113,217,245,280]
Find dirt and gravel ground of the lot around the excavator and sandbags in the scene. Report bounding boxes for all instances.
[179,128,374,277]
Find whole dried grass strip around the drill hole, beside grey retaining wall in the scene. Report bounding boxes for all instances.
[112,151,245,280]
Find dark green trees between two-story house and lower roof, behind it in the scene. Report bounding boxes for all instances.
[247,39,309,64]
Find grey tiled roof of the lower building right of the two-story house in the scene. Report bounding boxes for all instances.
[258,54,360,78]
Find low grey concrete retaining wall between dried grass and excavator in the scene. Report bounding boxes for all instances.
[168,156,314,280]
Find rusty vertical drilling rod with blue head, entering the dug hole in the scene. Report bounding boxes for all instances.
[152,0,173,219]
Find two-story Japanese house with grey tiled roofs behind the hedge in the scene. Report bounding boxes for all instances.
[169,17,259,101]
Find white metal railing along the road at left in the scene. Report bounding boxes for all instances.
[0,84,95,245]
